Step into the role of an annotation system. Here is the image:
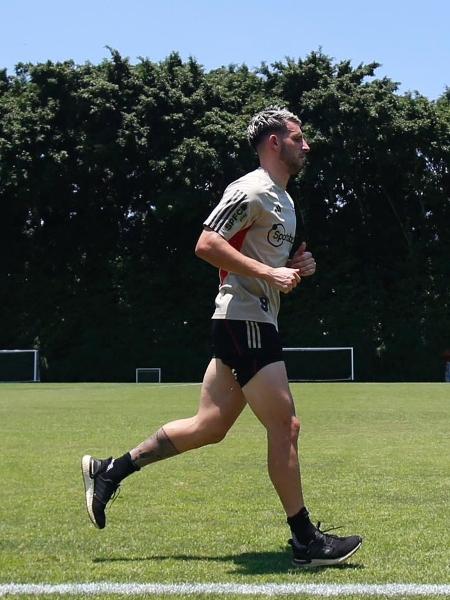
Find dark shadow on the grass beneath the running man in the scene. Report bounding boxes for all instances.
[93,550,364,575]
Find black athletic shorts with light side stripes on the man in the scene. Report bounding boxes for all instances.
[212,319,283,387]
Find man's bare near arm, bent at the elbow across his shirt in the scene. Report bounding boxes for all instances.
[195,229,300,294]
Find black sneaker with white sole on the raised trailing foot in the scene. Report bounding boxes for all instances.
[81,454,119,529]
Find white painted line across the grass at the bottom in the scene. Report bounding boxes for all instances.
[0,582,450,598]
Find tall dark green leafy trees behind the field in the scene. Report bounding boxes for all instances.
[0,50,450,381]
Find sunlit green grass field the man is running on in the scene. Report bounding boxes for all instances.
[0,383,450,599]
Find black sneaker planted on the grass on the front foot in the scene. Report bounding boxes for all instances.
[289,523,362,567]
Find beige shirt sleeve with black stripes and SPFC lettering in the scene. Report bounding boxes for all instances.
[203,188,261,240]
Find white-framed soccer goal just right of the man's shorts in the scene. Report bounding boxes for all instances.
[283,346,355,381]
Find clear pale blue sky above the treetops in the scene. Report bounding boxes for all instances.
[0,0,450,99]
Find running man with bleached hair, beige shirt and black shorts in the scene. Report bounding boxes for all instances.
[82,107,362,567]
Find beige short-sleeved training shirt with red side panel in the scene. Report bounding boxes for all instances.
[204,167,296,327]
